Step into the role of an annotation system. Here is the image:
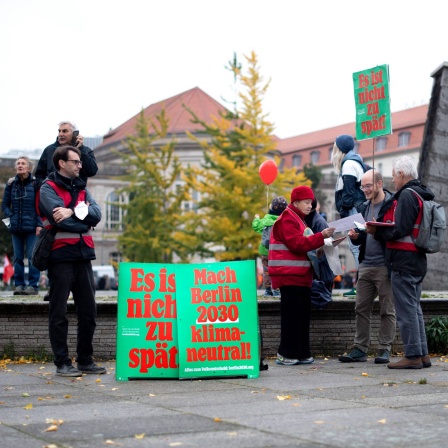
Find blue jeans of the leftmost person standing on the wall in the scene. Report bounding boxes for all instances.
[11,232,40,288]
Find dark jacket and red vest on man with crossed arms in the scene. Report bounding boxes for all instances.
[38,171,101,263]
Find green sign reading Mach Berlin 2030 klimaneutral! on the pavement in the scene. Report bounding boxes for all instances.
[176,261,260,378]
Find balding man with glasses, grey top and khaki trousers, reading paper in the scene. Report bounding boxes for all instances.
[339,170,396,364]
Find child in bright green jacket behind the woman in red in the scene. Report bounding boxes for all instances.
[252,196,288,296]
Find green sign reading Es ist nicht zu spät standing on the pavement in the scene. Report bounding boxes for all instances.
[116,263,179,381]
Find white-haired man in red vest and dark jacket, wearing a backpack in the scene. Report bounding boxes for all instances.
[366,156,434,369]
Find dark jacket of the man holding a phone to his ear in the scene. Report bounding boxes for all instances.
[34,139,98,183]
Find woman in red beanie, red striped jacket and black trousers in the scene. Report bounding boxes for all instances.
[268,186,335,365]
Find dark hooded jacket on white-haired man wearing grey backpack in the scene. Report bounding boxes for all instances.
[375,179,434,275]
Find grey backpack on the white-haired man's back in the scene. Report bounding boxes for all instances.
[407,188,446,254]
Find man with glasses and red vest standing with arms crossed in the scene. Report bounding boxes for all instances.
[38,146,106,377]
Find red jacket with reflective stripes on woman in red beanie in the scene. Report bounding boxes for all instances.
[268,204,324,289]
